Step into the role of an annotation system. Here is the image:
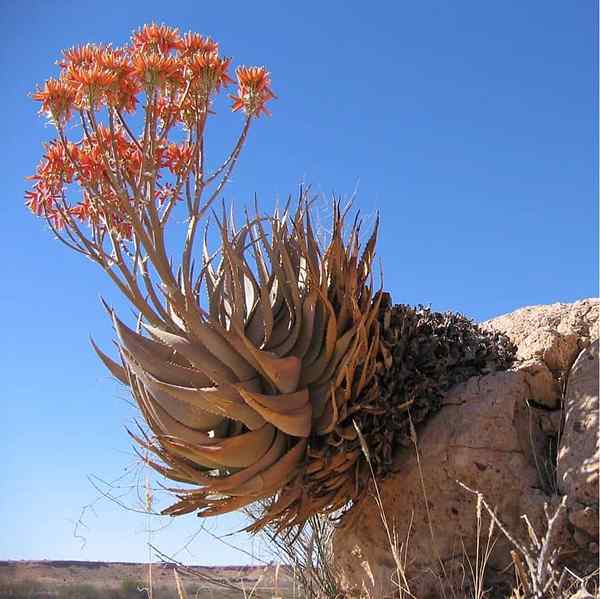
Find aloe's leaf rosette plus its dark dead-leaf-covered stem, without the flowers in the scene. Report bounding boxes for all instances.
[101,196,514,531]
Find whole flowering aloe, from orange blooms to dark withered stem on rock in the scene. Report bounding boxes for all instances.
[26,25,514,530]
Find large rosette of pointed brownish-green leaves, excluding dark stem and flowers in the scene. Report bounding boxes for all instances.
[98,197,382,528]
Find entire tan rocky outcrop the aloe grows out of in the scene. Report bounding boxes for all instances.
[334,300,600,599]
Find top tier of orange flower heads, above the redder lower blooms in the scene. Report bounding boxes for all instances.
[33,24,275,124]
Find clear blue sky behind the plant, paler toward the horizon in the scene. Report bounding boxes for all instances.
[0,0,598,564]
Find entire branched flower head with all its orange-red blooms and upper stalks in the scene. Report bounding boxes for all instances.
[25,24,275,262]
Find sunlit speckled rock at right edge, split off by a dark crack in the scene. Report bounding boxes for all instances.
[558,341,600,506]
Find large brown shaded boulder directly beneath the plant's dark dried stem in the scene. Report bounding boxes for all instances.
[335,372,543,597]
